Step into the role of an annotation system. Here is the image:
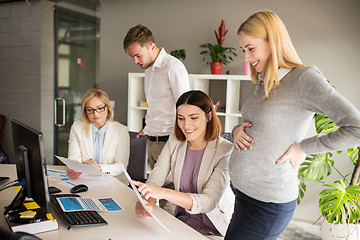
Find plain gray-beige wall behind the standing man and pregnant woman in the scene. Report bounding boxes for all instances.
[100,0,360,221]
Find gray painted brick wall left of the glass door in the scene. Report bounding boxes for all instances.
[0,0,54,163]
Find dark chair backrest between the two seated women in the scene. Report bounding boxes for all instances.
[127,132,148,181]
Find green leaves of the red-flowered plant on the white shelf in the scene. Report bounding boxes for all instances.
[199,43,237,65]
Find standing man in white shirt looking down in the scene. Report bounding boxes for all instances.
[123,25,190,168]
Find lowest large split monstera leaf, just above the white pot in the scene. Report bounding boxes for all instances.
[319,180,360,224]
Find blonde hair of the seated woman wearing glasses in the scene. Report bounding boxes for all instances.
[81,88,114,134]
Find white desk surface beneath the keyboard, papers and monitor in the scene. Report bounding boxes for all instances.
[0,164,207,240]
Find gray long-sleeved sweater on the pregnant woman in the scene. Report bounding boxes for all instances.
[229,66,360,203]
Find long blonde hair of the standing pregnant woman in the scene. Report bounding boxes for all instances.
[237,10,303,99]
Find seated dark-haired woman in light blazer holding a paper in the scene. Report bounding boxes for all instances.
[134,91,234,236]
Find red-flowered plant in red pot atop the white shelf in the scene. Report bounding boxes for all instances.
[199,20,237,74]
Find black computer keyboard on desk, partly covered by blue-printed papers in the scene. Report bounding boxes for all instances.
[50,194,107,227]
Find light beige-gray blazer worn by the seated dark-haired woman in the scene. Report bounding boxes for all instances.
[147,135,235,235]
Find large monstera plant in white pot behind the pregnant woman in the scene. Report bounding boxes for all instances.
[298,82,360,239]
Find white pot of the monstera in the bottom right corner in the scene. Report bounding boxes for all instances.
[322,222,360,240]
